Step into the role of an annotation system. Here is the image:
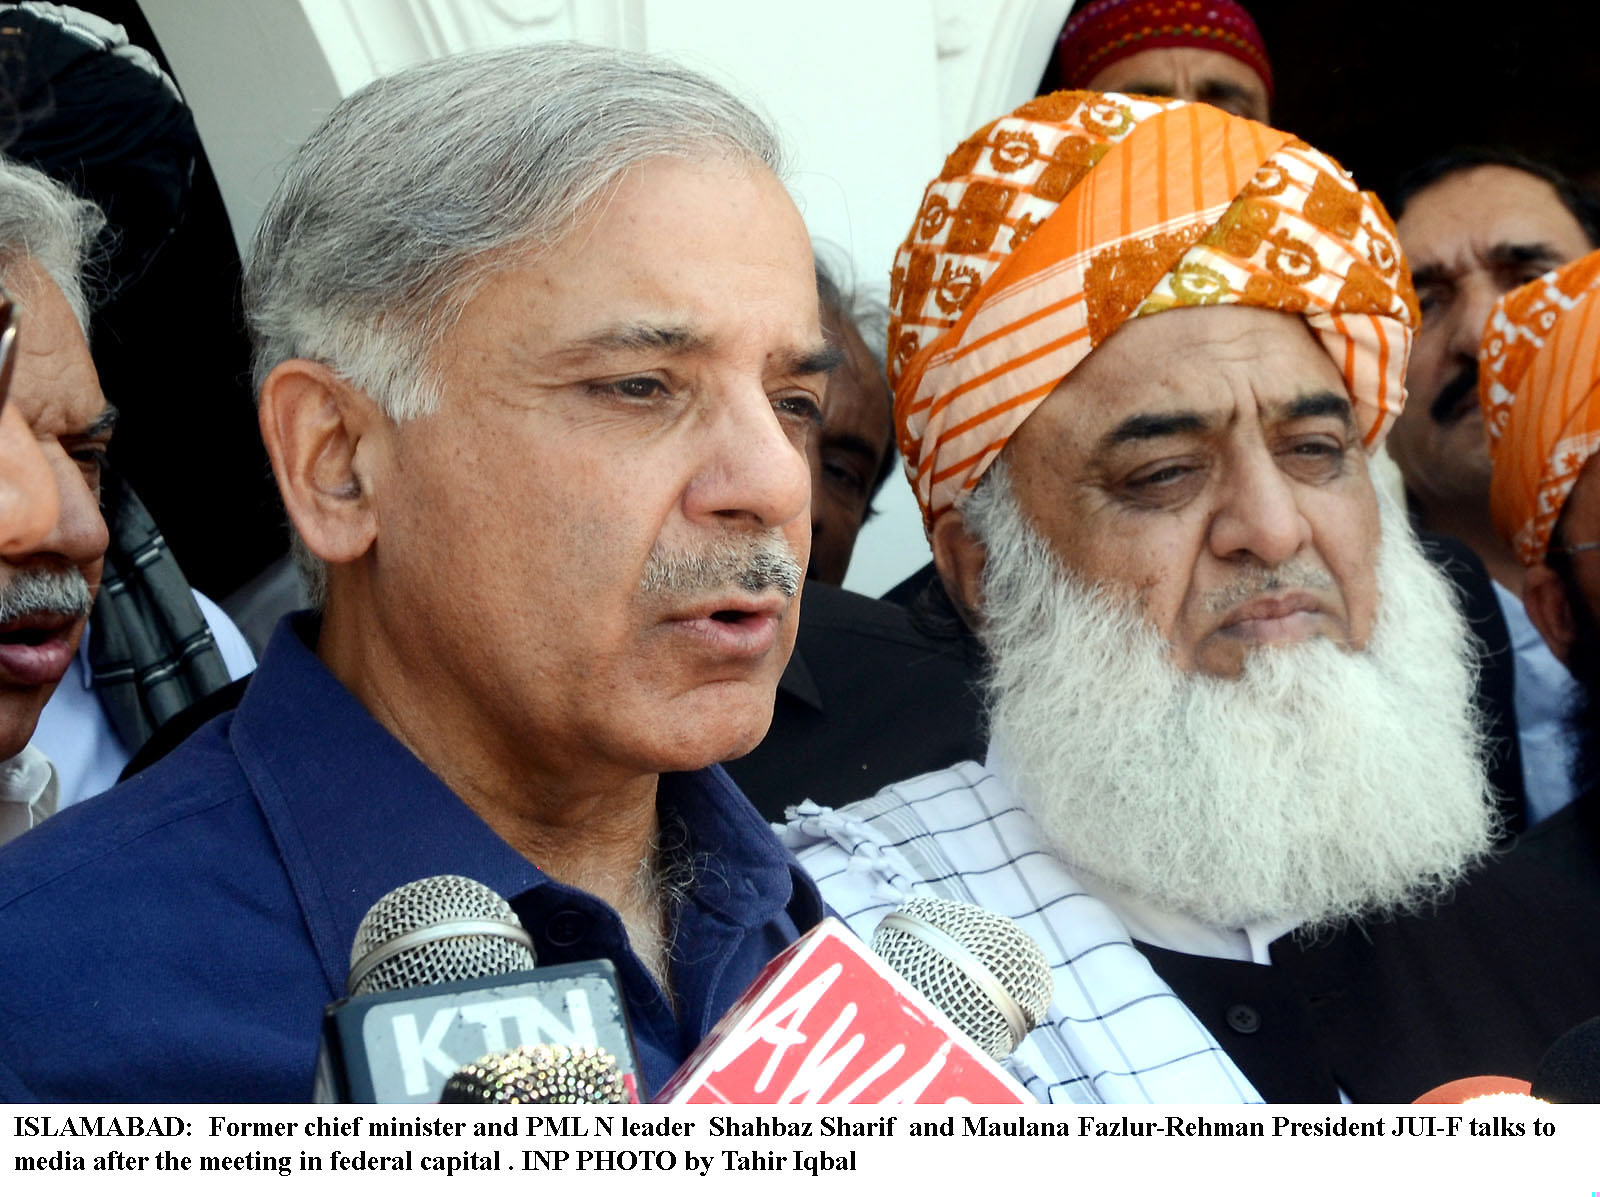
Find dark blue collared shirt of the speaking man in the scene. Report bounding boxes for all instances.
[0,616,822,1101]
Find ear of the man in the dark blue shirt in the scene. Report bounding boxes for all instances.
[258,357,389,563]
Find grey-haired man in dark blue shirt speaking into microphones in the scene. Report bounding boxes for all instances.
[0,45,838,1101]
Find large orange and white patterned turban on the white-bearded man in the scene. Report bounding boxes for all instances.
[890,91,1416,528]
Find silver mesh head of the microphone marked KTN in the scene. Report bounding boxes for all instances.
[346,875,534,997]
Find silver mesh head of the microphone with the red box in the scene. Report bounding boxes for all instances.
[872,898,1054,1059]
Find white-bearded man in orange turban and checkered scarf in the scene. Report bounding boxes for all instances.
[789,93,1600,1101]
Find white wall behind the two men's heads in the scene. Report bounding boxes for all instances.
[142,0,1070,594]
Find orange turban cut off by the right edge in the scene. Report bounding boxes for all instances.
[1478,251,1600,565]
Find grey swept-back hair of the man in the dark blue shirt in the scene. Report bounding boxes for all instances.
[245,42,781,421]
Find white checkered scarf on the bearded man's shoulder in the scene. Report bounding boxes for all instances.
[781,762,1261,1103]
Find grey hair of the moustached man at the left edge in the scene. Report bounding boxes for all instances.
[0,155,106,336]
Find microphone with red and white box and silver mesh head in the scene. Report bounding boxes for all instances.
[656,898,1051,1106]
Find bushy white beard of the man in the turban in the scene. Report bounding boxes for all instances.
[963,462,1494,930]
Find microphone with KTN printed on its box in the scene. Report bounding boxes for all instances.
[312,875,638,1103]
